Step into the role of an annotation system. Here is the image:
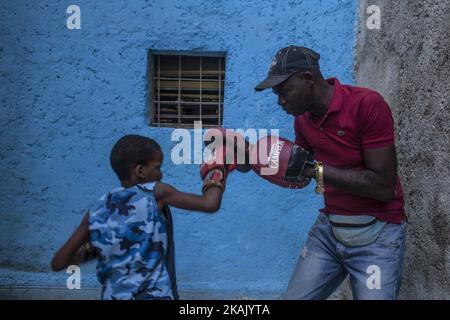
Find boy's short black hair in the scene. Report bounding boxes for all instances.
[109,134,161,181]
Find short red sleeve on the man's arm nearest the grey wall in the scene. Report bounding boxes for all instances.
[359,93,394,149]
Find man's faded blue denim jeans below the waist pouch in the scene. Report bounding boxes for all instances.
[283,213,406,300]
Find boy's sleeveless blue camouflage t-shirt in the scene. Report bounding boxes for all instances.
[89,182,176,300]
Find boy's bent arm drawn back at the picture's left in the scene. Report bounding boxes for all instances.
[51,213,89,271]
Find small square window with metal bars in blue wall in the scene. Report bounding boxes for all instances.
[149,52,225,128]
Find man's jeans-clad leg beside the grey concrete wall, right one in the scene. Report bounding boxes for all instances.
[345,222,406,300]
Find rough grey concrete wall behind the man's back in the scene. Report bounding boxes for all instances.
[355,0,450,299]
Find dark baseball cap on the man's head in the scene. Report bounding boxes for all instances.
[255,45,320,91]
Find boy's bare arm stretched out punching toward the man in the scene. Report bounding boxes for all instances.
[155,182,223,213]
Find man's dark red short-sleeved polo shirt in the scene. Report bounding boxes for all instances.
[294,78,404,223]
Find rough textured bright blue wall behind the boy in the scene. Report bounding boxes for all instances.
[0,0,356,297]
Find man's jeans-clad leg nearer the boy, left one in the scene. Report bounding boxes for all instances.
[283,214,347,300]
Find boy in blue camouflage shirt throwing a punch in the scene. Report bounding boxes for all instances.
[51,135,235,299]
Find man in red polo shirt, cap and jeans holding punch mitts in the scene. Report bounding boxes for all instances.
[255,46,406,299]
